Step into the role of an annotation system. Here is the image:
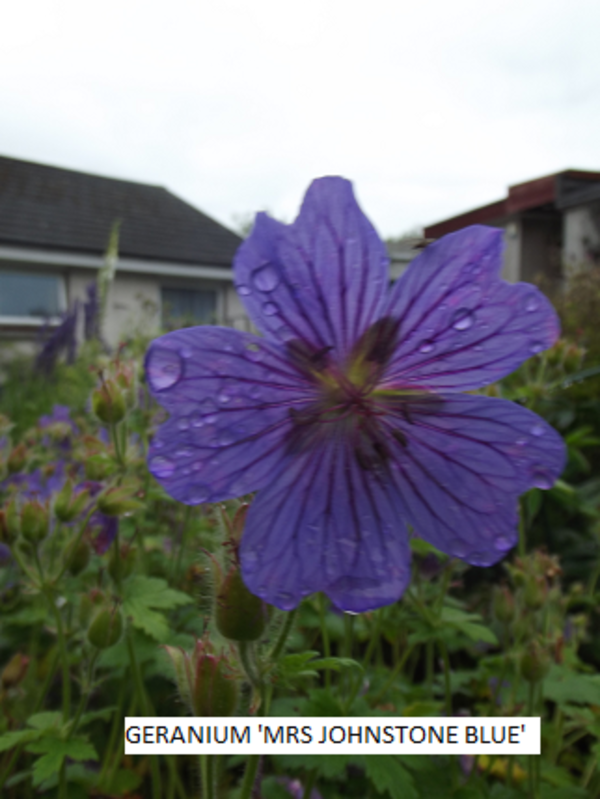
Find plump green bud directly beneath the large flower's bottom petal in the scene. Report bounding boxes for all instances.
[216,565,268,641]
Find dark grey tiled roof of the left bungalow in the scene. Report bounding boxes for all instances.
[0,156,242,266]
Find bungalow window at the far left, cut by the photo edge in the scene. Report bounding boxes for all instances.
[0,271,64,318]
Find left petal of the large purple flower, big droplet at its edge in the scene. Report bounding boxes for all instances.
[146,326,314,505]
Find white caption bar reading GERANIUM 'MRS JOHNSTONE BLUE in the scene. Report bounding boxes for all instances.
[125,716,540,755]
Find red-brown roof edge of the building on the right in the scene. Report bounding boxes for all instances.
[424,169,600,238]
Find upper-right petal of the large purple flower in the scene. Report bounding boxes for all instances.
[384,225,559,391]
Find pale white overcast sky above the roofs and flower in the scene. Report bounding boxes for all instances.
[0,0,600,237]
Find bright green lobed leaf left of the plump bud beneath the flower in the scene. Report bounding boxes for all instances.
[123,575,193,643]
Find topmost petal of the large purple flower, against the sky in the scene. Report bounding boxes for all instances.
[234,177,388,357]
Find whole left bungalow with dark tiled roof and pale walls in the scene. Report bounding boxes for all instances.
[0,157,249,354]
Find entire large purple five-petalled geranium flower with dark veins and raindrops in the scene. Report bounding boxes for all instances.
[146,177,565,612]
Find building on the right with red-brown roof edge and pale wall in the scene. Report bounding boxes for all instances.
[424,169,600,281]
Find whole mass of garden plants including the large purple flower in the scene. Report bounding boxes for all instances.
[0,178,600,799]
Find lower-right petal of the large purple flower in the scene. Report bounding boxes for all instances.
[386,394,565,566]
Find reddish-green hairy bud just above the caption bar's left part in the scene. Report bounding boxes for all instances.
[165,641,239,716]
